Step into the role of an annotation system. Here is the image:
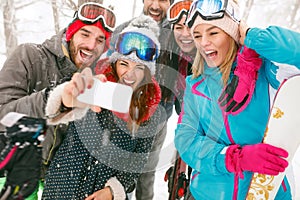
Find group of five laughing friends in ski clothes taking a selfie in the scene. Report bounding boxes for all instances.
[0,0,300,200]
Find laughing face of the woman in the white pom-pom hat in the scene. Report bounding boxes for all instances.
[116,59,146,89]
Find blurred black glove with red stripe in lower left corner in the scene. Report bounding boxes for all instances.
[0,116,46,199]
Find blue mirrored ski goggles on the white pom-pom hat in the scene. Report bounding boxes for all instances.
[116,32,159,61]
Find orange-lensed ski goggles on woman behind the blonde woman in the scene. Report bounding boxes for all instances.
[167,0,192,24]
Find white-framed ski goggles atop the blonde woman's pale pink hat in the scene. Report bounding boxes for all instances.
[186,0,240,28]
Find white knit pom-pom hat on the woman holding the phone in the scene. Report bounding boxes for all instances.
[109,14,160,75]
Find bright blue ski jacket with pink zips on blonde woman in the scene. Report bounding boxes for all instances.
[175,26,300,200]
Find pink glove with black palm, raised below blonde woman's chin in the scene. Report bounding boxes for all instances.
[218,46,262,114]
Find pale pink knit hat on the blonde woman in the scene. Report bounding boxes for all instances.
[191,0,240,44]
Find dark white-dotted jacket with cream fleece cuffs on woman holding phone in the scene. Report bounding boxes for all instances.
[43,70,161,199]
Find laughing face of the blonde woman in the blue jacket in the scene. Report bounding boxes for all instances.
[193,24,231,67]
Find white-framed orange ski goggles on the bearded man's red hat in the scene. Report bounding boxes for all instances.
[75,2,116,32]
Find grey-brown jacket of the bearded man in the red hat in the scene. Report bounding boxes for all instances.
[0,28,77,177]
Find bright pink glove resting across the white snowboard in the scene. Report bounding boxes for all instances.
[225,143,288,175]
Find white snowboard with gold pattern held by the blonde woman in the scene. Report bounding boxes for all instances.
[247,75,300,200]
